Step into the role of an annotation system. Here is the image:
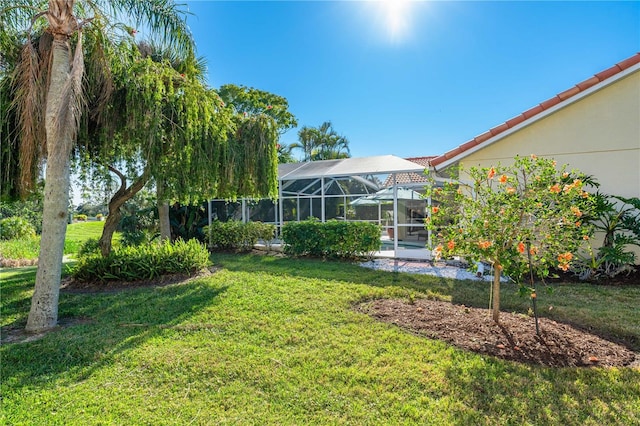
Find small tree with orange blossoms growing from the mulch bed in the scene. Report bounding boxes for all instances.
[427,155,592,323]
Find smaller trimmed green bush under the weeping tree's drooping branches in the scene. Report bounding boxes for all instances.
[204,220,275,251]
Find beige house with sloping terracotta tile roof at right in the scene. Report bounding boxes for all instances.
[429,53,640,197]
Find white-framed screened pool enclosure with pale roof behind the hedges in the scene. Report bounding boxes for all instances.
[209,155,430,252]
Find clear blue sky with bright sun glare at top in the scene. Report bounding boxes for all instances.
[180,0,640,157]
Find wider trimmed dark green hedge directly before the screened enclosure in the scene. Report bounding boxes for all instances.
[282,219,381,259]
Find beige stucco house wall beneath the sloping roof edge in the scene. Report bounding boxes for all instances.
[462,71,640,197]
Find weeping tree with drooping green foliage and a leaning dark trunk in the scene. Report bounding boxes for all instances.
[78,46,278,256]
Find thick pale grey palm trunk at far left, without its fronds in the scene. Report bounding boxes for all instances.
[26,34,75,332]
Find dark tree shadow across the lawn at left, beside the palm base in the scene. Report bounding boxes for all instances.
[0,280,227,387]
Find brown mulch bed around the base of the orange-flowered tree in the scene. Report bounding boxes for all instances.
[358,299,640,367]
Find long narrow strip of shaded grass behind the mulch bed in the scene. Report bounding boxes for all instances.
[212,253,640,352]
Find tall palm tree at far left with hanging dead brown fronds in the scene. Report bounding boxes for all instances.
[0,0,193,332]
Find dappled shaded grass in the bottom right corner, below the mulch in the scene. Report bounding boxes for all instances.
[445,353,640,425]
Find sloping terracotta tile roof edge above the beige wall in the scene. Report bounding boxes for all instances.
[428,53,640,170]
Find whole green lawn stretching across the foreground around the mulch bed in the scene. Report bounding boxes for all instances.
[0,255,640,425]
